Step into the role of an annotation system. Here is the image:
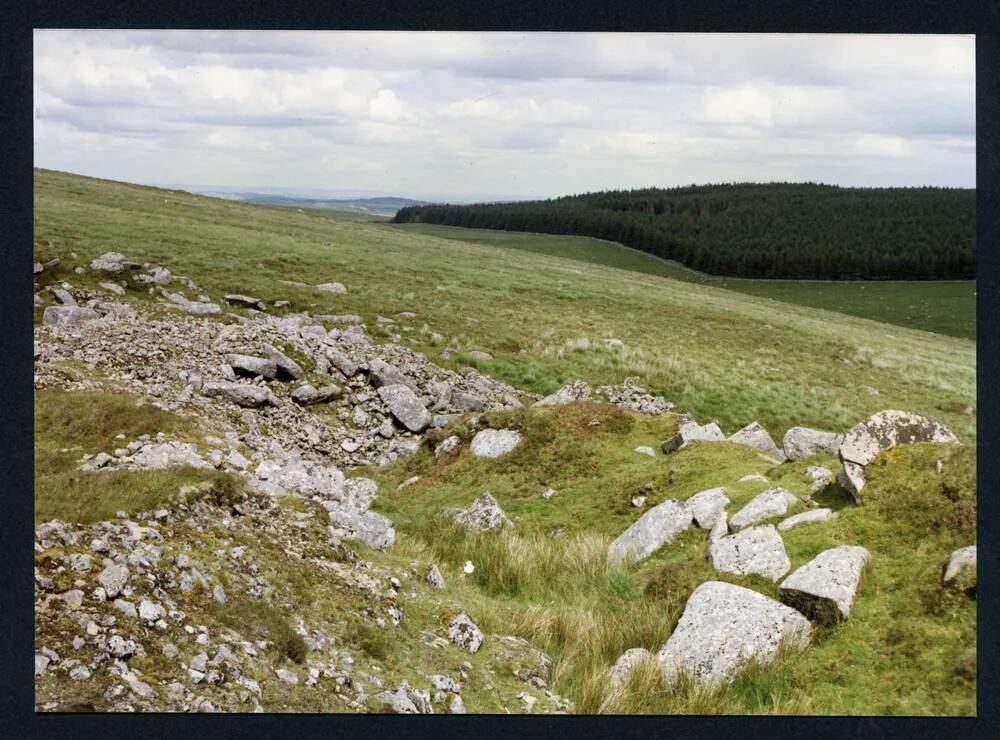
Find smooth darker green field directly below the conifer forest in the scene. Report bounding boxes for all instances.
[397,224,976,339]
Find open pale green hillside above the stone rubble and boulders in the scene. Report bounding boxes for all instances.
[35,171,975,440]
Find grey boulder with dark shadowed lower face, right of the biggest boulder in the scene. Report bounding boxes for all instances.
[778,545,871,625]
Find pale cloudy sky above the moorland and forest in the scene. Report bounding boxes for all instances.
[34,30,976,201]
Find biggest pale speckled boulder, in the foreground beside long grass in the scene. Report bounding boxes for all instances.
[656,581,813,689]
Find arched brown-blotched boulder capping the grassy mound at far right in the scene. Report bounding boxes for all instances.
[837,409,958,504]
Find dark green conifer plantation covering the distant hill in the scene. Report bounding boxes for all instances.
[394,183,975,280]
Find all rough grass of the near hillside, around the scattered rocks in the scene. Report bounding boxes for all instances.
[34,170,976,715]
